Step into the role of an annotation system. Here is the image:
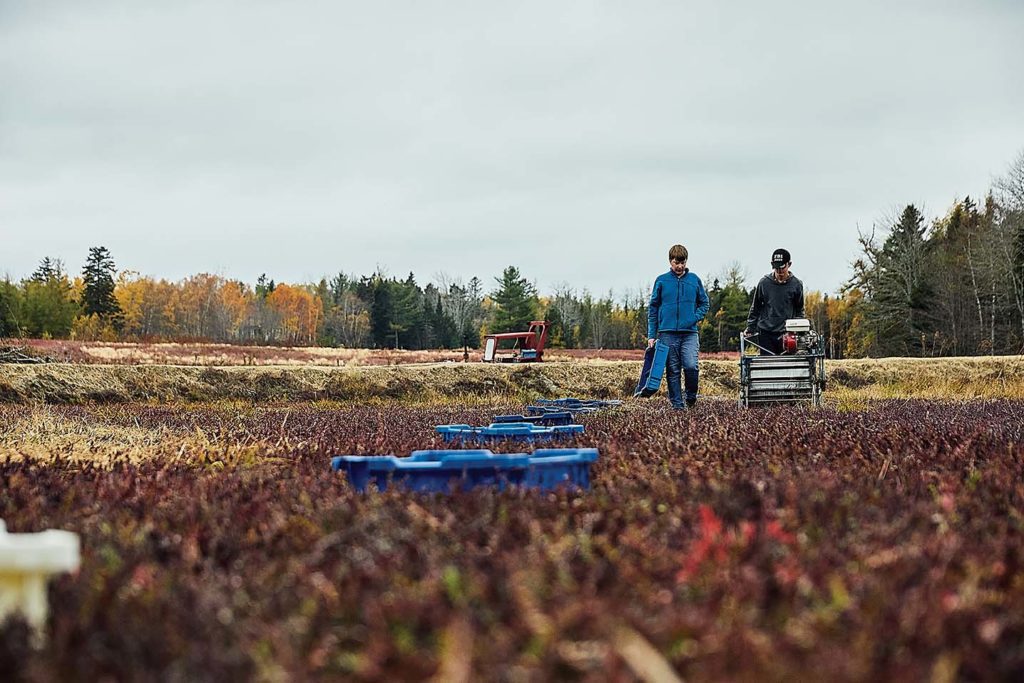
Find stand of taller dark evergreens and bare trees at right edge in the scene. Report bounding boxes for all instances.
[847,159,1024,355]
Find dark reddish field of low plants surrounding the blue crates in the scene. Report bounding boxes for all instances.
[0,398,1024,681]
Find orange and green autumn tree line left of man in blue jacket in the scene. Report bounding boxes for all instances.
[0,255,646,349]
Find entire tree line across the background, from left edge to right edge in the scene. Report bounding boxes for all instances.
[0,154,1024,357]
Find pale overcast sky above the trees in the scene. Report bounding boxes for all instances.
[0,0,1024,295]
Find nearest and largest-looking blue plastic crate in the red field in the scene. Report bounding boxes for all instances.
[331,449,598,493]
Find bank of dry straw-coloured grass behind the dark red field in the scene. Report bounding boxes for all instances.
[0,356,1024,404]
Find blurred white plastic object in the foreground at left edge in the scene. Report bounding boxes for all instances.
[0,519,80,633]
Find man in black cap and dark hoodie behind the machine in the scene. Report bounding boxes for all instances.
[743,249,804,354]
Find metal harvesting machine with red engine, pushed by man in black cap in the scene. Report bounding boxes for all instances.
[739,317,825,408]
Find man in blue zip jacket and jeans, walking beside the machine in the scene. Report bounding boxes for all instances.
[647,245,711,410]
